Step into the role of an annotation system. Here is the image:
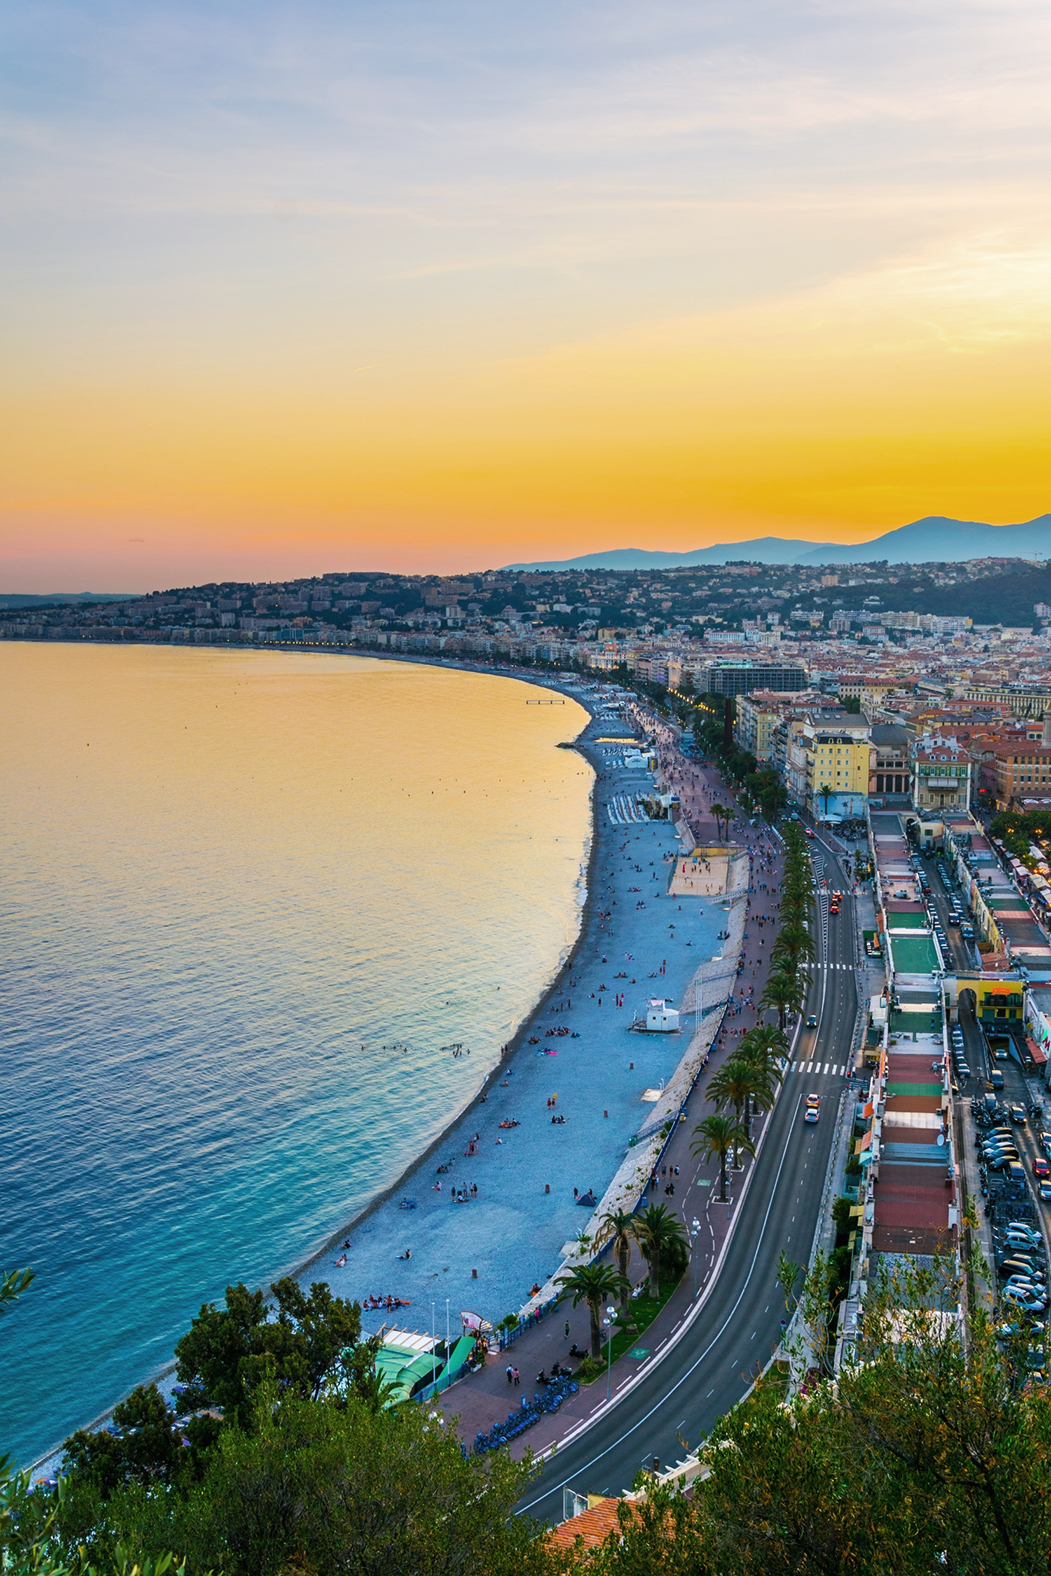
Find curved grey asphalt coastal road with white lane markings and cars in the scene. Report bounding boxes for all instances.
[517,843,857,1524]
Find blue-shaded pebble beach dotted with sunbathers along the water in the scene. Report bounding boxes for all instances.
[301,699,726,1335]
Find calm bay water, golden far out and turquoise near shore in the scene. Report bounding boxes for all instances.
[0,643,591,1461]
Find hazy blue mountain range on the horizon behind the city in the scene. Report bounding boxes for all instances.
[504,514,1051,569]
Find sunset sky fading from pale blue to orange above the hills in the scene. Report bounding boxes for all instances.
[0,0,1051,591]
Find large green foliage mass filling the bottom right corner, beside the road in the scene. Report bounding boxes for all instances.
[588,1248,1051,1576]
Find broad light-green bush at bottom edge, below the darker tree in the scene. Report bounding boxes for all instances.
[44,1382,545,1576]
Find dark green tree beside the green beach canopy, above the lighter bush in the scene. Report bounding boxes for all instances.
[175,1277,361,1417]
